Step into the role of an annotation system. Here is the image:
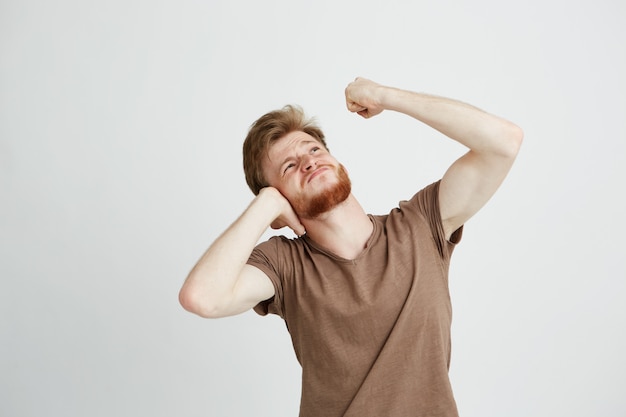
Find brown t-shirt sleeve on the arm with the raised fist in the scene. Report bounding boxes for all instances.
[411,180,463,258]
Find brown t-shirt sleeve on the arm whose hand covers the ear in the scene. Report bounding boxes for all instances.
[247,237,283,317]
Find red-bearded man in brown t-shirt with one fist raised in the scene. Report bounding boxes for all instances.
[180,78,523,417]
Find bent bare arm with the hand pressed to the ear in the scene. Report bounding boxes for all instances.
[179,187,304,318]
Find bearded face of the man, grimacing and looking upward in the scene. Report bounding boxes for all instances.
[263,131,351,219]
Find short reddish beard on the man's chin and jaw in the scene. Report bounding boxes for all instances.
[291,165,352,219]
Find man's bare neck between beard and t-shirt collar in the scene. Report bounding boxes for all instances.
[301,194,373,259]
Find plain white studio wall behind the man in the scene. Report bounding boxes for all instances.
[0,0,626,417]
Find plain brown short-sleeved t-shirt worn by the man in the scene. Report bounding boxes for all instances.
[248,182,462,417]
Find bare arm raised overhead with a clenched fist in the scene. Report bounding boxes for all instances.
[345,78,523,238]
